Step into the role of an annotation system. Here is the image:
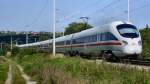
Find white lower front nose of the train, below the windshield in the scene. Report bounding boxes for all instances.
[123,41,142,55]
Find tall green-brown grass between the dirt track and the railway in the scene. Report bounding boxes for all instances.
[11,54,150,84]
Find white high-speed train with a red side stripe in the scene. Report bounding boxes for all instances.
[18,21,142,59]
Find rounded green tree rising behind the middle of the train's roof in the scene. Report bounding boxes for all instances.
[65,22,92,35]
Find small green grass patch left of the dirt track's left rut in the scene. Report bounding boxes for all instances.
[0,63,8,84]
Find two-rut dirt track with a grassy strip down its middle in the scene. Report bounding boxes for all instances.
[1,57,36,84]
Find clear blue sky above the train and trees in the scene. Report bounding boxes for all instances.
[0,0,150,32]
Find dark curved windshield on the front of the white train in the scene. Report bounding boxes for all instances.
[117,24,139,38]
